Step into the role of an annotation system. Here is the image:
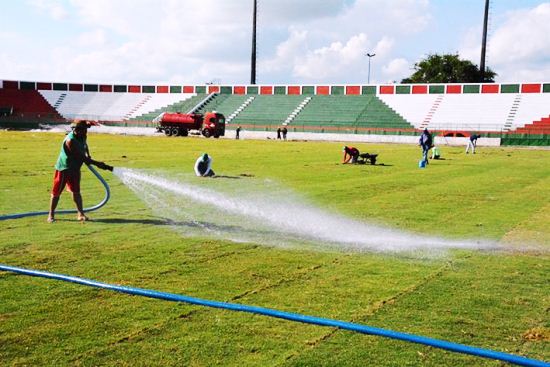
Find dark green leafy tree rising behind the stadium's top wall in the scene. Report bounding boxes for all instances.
[401,54,497,84]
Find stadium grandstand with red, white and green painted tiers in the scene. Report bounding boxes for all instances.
[0,80,550,145]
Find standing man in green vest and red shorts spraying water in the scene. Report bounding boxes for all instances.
[48,120,112,223]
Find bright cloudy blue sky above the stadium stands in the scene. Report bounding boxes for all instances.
[0,0,550,85]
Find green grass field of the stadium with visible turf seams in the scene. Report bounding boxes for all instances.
[0,131,550,366]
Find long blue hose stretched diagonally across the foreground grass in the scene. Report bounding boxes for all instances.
[0,264,550,367]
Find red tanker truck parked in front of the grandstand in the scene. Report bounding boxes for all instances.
[153,111,225,138]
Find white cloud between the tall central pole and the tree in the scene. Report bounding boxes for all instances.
[263,0,431,83]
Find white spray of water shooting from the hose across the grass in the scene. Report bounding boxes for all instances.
[114,168,499,256]
